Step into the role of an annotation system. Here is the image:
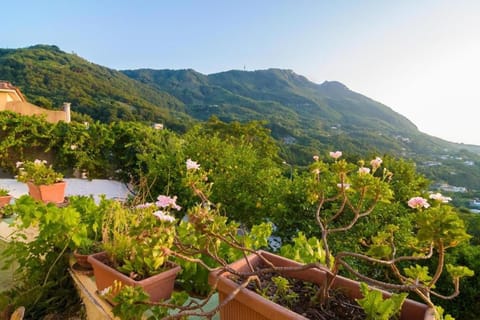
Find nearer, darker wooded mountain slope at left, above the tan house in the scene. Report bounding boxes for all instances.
[0,45,190,128]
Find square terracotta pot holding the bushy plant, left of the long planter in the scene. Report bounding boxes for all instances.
[88,252,181,302]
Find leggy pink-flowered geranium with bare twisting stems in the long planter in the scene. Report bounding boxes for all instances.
[187,151,473,317]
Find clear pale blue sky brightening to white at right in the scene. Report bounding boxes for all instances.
[0,0,480,145]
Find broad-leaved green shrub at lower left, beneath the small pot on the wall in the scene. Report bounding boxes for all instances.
[2,196,87,319]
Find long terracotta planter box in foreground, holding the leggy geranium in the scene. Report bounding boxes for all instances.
[209,251,435,320]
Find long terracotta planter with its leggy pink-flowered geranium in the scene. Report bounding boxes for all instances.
[181,151,472,320]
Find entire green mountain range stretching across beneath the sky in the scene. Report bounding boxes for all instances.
[0,45,480,190]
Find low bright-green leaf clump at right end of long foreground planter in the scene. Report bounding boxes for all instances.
[356,282,408,320]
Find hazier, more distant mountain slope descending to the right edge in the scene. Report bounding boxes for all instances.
[122,69,480,190]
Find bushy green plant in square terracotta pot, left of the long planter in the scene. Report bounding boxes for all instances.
[88,196,181,302]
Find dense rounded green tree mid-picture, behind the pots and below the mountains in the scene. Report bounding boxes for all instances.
[184,120,287,226]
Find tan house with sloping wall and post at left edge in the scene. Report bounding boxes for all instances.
[0,80,70,123]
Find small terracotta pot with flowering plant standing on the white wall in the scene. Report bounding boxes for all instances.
[16,159,66,203]
